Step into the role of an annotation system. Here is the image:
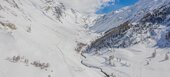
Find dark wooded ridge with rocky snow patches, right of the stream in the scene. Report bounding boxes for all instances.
[88,0,170,51]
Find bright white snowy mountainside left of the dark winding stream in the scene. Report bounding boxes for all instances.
[0,0,103,77]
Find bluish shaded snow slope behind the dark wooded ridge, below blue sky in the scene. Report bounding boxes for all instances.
[90,0,167,33]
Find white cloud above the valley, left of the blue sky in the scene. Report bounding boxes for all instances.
[59,0,114,13]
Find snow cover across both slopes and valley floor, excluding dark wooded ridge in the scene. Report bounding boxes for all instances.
[0,0,170,77]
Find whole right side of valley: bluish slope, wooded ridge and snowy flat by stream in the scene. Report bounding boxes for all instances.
[82,0,170,77]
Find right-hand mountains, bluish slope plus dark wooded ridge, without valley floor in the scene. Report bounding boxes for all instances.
[85,0,170,50]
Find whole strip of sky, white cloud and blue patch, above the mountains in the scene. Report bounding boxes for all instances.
[58,0,138,14]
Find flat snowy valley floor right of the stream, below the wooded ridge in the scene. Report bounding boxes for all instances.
[83,45,170,77]
